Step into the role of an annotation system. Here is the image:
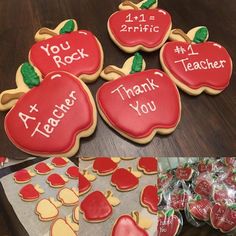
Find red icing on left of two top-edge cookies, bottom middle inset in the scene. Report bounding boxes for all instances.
[93,157,118,174]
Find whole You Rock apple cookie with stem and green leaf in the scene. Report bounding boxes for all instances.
[29,20,103,82]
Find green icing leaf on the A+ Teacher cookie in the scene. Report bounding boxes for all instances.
[20,62,40,88]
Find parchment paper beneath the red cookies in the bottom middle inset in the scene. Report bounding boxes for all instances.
[79,158,157,236]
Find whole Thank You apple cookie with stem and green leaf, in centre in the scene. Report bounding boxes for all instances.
[96,53,181,144]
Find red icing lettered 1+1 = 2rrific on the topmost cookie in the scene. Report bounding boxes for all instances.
[108,9,172,48]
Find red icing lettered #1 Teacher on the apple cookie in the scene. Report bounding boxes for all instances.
[161,42,232,90]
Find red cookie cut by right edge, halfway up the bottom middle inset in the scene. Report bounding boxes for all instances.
[140,185,159,215]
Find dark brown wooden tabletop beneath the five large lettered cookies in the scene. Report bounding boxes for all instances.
[0,0,236,235]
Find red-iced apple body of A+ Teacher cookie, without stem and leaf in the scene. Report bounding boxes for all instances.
[4,72,97,157]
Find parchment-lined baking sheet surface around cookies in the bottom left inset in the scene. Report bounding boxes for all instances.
[1,158,78,236]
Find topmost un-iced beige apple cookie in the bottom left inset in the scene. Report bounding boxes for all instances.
[57,188,79,206]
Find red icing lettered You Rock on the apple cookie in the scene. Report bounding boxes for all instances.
[29,30,102,77]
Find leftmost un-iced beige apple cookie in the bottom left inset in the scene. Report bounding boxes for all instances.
[35,198,62,221]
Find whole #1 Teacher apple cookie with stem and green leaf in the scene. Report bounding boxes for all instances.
[160,26,232,95]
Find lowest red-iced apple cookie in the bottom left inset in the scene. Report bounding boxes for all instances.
[19,184,44,202]
